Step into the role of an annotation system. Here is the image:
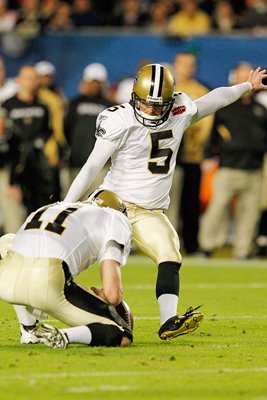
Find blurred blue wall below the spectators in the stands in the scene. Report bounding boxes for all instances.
[1,30,267,98]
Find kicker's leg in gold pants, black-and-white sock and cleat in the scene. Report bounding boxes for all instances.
[128,207,203,340]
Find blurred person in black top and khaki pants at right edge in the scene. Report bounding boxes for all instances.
[199,63,267,260]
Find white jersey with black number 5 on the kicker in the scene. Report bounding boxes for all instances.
[96,93,197,209]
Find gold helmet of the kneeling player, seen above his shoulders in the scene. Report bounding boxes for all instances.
[88,189,126,214]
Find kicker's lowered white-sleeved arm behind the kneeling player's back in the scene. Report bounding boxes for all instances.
[64,138,114,203]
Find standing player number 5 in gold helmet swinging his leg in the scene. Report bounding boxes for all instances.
[65,64,267,340]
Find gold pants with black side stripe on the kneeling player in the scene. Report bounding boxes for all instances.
[0,251,118,326]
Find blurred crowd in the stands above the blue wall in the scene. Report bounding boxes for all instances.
[0,0,267,38]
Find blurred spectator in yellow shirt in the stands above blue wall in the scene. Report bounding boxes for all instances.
[167,0,211,36]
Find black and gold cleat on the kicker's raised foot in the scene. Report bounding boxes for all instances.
[158,306,204,340]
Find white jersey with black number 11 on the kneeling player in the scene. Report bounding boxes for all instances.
[11,202,131,276]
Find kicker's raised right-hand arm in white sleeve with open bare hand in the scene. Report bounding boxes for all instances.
[191,67,267,125]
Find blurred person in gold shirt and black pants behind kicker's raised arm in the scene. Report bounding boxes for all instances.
[167,52,213,254]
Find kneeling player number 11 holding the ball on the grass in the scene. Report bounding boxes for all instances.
[0,191,133,348]
